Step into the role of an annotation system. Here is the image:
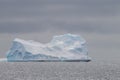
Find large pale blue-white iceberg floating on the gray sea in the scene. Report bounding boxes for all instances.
[7,34,91,61]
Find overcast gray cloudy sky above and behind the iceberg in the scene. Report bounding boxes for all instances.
[0,0,120,61]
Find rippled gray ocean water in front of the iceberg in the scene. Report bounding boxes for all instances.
[0,62,120,80]
